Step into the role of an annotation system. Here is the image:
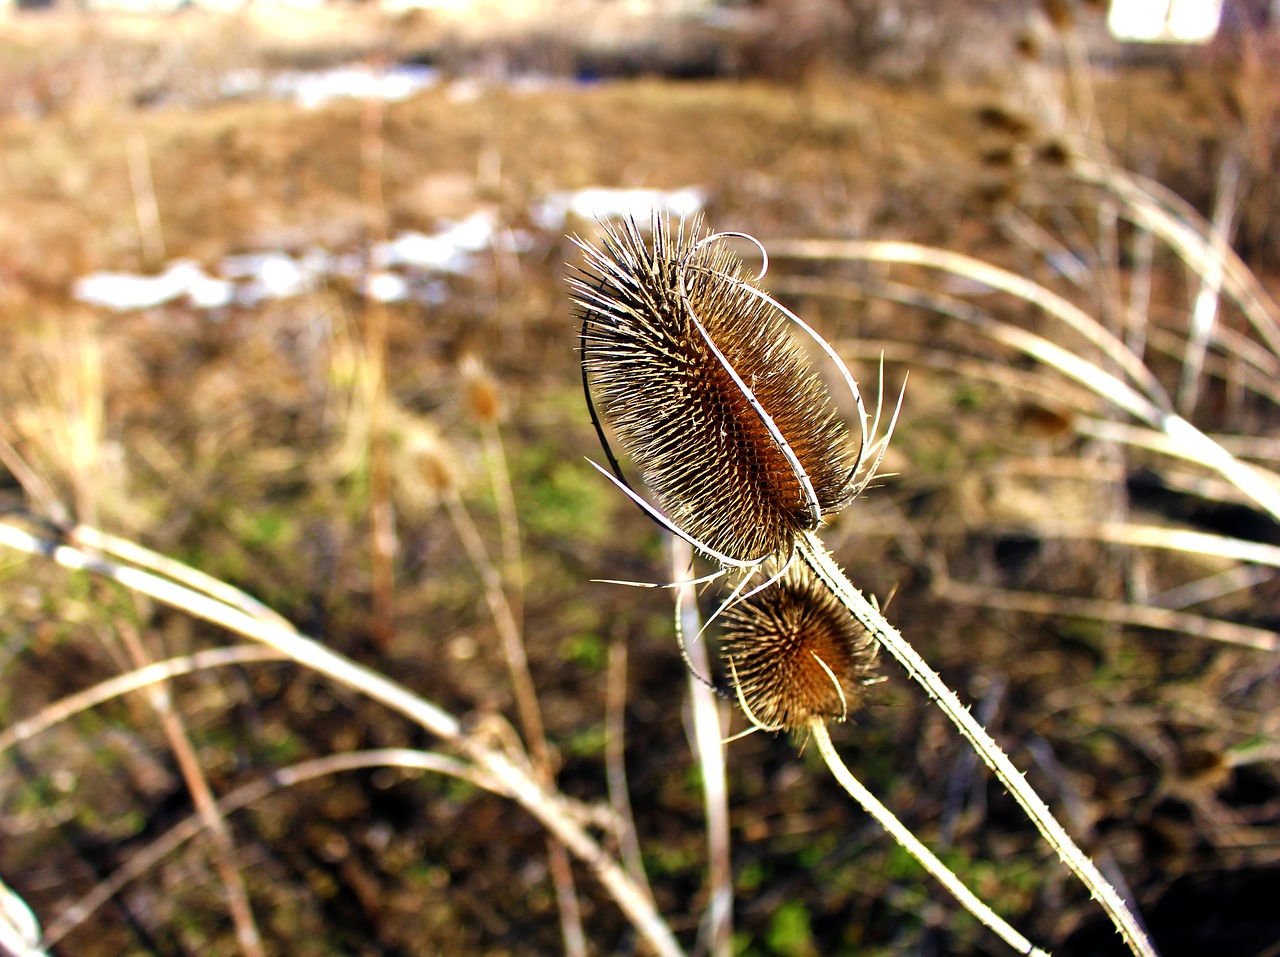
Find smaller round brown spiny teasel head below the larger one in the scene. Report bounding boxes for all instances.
[721,563,877,731]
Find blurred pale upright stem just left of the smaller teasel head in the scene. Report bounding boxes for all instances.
[669,535,733,957]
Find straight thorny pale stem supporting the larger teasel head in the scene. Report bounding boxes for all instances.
[797,532,1156,957]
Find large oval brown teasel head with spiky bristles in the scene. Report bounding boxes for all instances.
[572,218,851,562]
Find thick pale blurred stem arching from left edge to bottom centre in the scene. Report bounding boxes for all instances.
[0,522,684,957]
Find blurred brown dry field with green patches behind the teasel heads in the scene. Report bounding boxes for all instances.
[0,7,1280,957]
